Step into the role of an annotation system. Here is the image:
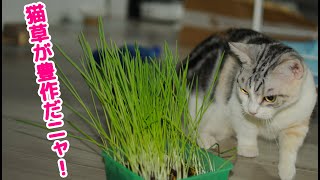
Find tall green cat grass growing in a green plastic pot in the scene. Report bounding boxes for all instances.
[52,19,233,180]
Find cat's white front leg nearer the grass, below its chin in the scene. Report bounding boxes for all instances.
[235,121,259,157]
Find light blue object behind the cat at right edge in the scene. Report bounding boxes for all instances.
[283,40,318,87]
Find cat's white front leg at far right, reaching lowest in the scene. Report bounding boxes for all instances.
[278,120,309,180]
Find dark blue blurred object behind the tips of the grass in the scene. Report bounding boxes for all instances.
[93,44,161,64]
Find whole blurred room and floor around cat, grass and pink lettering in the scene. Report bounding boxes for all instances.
[2,0,318,180]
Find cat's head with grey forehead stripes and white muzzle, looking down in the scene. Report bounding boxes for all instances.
[229,43,305,120]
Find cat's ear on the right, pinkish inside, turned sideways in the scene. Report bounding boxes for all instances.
[275,59,304,80]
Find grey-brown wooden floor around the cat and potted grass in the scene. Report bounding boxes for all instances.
[2,17,318,180]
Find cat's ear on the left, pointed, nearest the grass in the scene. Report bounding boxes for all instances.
[228,42,252,65]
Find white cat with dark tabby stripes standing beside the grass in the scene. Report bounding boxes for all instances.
[177,28,317,180]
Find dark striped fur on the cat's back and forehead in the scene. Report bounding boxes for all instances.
[179,29,301,103]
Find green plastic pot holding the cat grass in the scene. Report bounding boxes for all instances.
[102,151,233,180]
